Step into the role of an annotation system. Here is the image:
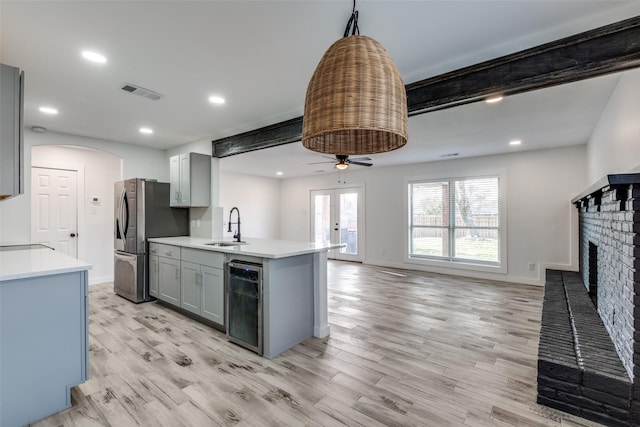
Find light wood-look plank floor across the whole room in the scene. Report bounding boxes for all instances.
[33,262,597,427]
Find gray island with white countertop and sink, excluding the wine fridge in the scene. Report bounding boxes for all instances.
[148,236,344,358]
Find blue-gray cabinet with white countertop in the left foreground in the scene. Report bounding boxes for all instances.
[0,245,91,427]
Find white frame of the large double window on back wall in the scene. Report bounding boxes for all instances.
[404,171,507,274]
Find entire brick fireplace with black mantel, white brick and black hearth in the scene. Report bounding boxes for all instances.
[538,174,640,426]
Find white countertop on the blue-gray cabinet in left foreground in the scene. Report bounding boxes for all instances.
[0,248,91,282]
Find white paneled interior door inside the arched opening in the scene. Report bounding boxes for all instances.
[31,167,78,258]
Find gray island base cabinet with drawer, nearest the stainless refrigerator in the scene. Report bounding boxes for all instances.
[155,243,180,306]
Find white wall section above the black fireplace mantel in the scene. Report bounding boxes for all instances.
[588,70,640,184]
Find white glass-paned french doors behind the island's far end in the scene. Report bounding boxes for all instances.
[310,187,364,262]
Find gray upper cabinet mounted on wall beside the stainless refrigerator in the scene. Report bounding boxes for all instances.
[169,153,211,208]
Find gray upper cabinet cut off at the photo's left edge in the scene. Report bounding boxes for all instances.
[0,64,24,200]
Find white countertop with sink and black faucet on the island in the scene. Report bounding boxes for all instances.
[148,236,345,258]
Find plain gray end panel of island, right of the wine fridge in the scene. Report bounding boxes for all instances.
[263,254,314,358]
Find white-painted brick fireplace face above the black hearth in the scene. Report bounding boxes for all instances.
[575,175,640,379]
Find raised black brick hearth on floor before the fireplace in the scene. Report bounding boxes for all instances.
[537,270,638,426]
